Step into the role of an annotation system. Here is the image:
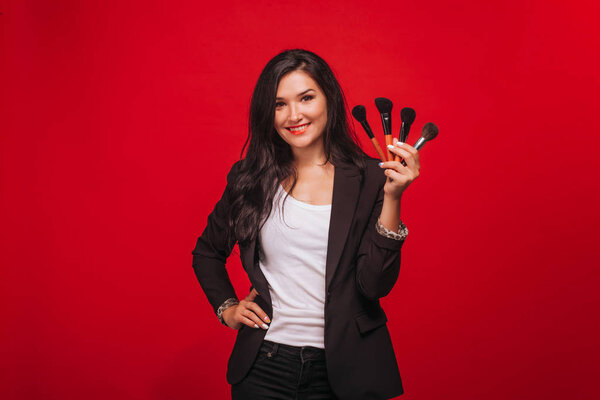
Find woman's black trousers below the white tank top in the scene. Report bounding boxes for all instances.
[231,340,337,400]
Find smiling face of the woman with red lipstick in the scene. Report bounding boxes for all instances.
[274,70,327,149]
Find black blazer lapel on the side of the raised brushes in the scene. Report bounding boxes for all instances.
[325,164,360,291]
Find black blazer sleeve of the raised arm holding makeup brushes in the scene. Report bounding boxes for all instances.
[356,181,404,300]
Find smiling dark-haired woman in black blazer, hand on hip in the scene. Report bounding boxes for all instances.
[193,50,419,400]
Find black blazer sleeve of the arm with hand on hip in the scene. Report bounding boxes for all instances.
[192,161,240,313]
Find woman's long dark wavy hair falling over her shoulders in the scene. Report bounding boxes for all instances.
[229,49,367,245]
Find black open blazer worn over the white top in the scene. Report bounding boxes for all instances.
[192,158,404,400]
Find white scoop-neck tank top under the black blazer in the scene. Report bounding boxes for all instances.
[259,185,331,348]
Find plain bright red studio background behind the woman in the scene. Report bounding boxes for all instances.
[0,0,600,400]
